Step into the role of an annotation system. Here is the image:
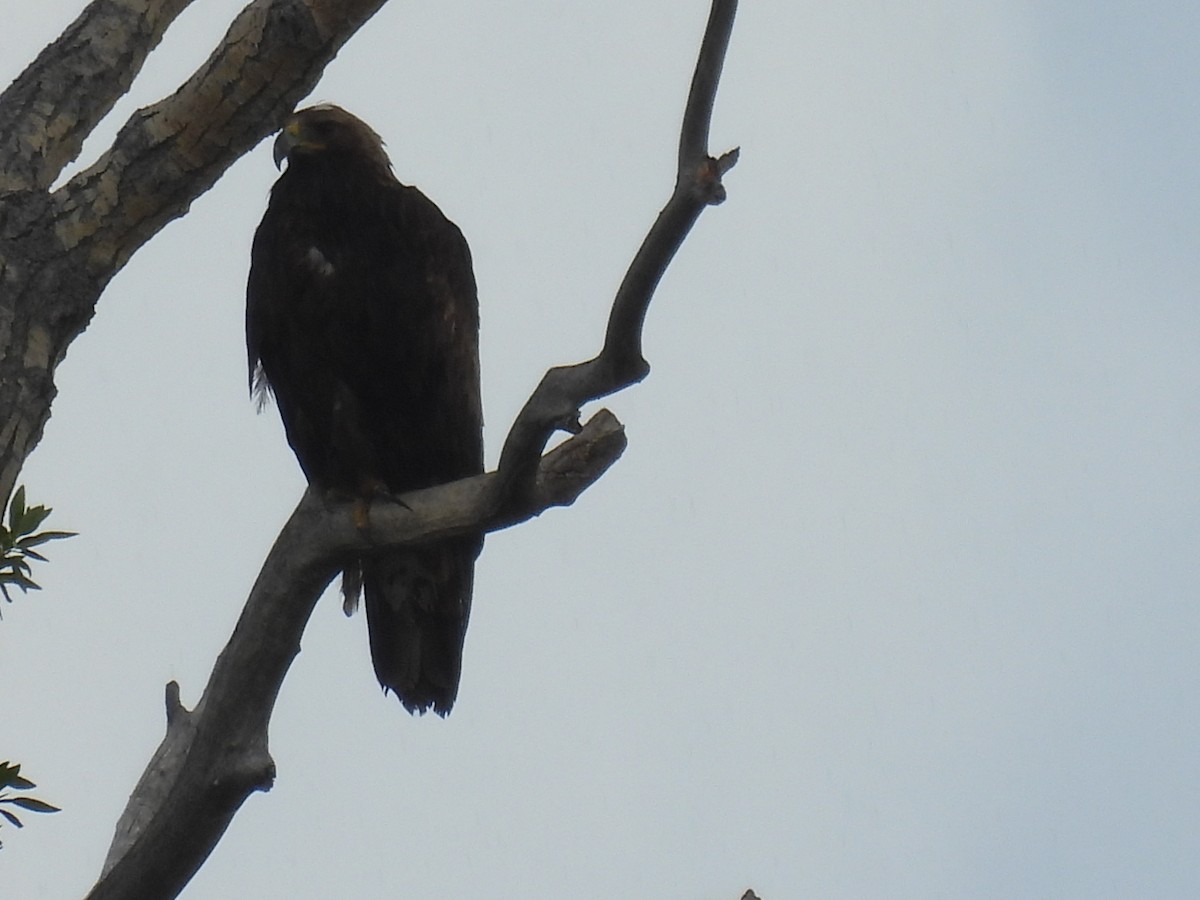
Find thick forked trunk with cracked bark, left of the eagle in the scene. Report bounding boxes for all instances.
[0,0,384,513]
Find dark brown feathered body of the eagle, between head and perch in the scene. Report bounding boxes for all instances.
[246,182,482,493]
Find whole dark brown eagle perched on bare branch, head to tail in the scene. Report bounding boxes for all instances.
[246,106,484,715]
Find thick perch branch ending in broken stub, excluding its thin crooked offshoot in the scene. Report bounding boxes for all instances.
[89,410,625,900]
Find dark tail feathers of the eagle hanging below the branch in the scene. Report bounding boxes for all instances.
[355,541,479,715]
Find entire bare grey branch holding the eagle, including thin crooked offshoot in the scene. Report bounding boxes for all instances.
[89,0,736,900]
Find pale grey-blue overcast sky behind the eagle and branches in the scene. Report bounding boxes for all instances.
[0,0,1200,900]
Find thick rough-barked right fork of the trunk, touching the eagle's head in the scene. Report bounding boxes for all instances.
[55,0,384,282]
